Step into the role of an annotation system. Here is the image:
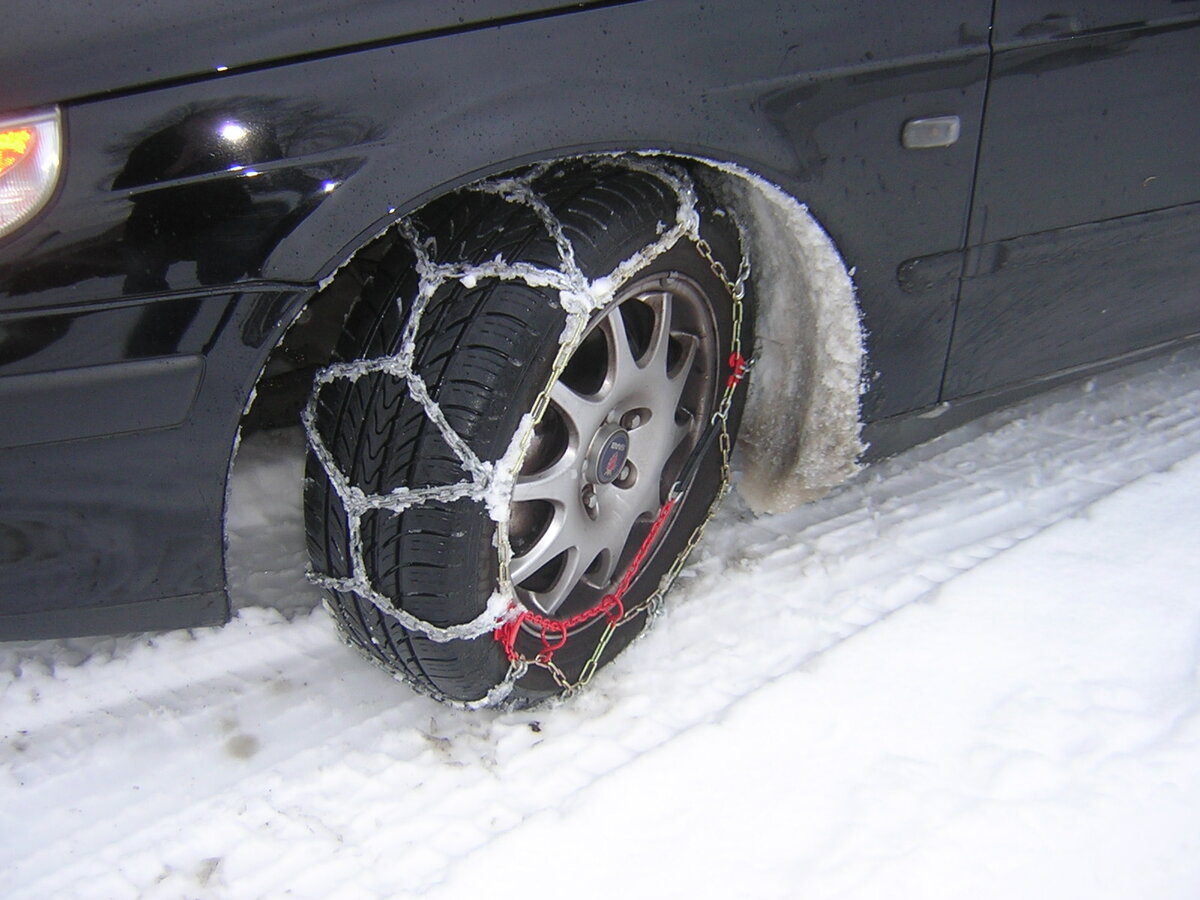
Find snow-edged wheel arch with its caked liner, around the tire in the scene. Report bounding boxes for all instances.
[236,149,864,528]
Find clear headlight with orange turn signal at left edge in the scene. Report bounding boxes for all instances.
[0,109,62,238]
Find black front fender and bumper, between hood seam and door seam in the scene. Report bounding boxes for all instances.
[0,0,991,636]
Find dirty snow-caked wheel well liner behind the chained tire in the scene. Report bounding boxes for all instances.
[701,161,865,512]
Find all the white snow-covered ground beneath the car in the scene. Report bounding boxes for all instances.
[0,340,1200,900]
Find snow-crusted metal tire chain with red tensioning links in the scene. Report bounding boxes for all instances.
[301,156,750,708]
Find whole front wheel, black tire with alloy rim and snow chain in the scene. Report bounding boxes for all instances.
[305,158,752,703]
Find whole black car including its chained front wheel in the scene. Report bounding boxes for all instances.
[0,0,1200,703]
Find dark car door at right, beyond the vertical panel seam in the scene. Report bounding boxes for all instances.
[943,0,1200,400]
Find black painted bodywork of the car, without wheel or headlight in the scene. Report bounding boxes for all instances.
[0,0,1200,637]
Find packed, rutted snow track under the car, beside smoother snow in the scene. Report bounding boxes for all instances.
[0,340,1200,896]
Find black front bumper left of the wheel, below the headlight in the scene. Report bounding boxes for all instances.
[0,286,304,637]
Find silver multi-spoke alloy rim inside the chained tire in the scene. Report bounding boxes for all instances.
[509,272,718,616]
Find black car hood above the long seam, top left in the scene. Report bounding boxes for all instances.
[0,0,636,109]
